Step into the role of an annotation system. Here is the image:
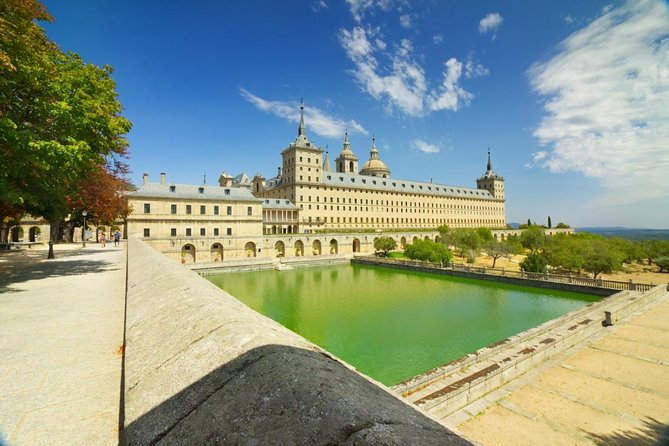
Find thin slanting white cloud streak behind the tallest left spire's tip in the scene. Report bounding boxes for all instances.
[239,88,369,138]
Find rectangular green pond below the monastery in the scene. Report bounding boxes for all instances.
[207,265,599,385]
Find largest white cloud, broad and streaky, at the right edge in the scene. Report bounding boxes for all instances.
[529,0,669,204]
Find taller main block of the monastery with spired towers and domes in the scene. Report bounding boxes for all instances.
[253,104,506,232]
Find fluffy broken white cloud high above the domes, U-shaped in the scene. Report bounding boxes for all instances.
[339,26,472,116]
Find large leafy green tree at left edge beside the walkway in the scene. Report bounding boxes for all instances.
[0,0,131,258]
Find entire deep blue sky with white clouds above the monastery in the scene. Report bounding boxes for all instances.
[44,0,669,228]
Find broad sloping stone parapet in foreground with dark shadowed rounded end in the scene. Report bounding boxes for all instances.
[121,238,470,445]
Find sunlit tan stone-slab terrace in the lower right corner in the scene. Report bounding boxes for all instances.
[443,294,669,445]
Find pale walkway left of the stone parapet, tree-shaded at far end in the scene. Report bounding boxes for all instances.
[0,243,126,446]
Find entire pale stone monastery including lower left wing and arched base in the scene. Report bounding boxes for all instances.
[127,103,506,263]
